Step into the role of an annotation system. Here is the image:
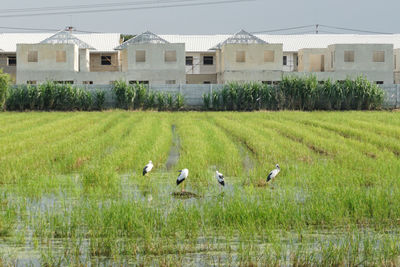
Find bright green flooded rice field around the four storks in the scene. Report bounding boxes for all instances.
[0,111,400,266]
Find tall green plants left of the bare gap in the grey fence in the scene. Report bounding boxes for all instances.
[0,80,184,111]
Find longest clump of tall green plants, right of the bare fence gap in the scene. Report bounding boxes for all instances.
[203,76,384,111]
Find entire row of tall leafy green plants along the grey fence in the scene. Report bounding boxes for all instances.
[0,70,384,111]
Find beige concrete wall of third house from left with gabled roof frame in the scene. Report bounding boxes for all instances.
[216,44,283,83]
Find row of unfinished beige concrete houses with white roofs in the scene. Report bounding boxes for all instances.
[0,29,400,85]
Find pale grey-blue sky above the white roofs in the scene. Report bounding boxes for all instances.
[0,0,400,34]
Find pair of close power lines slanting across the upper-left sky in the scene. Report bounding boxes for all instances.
[0,0,256,18]
